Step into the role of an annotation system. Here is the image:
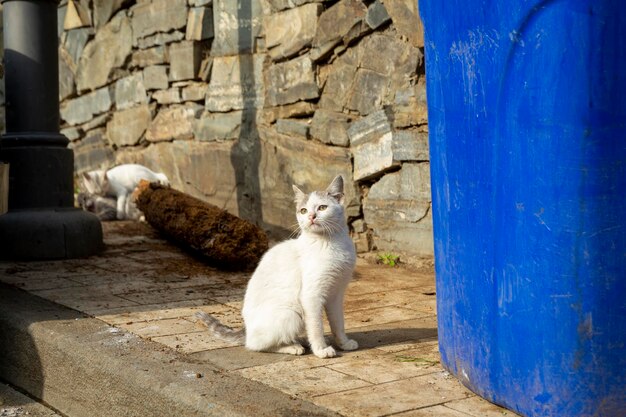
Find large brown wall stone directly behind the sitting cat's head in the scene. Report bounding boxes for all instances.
[258,126,360,237]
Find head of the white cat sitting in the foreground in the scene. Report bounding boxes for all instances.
[293,176,345,234]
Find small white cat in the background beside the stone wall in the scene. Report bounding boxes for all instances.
[83,164,169,220]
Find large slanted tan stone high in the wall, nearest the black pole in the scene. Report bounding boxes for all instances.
[76,11,132,91]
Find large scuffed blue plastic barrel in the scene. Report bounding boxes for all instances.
[419,0,626,417]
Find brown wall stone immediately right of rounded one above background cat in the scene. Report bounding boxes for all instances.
[145,104,202,142]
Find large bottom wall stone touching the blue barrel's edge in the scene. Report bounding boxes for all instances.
[363,163,433,255]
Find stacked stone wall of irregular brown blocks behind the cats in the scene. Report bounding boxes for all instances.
[2,0,432,255]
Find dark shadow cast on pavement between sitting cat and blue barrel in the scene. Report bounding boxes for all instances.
[347,327,437,349]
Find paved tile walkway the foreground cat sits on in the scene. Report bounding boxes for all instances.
[0,222,516,417]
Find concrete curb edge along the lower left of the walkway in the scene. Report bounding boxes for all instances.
[0,284,337,417]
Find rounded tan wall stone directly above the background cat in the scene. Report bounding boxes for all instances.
[107,104,152,147]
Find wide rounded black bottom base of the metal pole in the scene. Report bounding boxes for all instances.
[0,207,104,260]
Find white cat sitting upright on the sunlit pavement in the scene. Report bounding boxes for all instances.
[196,176,359,358]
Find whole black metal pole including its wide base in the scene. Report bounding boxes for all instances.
[0,0,102,259]
